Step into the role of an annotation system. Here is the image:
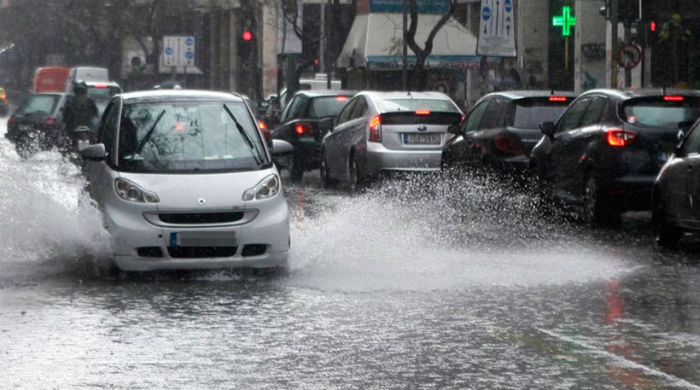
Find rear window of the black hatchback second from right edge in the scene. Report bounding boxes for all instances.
[622,96,700,128]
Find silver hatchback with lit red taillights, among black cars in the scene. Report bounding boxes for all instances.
[321,91,462,187]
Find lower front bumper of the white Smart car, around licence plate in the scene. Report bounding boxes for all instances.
[104,194,289,271]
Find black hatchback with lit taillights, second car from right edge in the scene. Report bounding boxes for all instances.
[530,89,700,225]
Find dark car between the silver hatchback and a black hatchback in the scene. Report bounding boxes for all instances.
[443,91,576,174]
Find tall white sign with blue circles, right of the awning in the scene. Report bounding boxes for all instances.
[476,0,517,57]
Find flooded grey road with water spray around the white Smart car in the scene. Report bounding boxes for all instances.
[0,117,700,389]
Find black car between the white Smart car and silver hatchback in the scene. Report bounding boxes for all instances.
[272,90,354,182]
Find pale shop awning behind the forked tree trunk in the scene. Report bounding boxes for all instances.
[338,13,498,70]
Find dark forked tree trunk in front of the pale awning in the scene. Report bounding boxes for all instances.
[404,0,457,90]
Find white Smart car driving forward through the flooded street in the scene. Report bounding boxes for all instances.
[81,90,289,271]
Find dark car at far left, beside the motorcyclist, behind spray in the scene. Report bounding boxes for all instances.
[5,93,70,158]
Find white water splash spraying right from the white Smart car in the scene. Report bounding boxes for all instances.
[290,172,626,291]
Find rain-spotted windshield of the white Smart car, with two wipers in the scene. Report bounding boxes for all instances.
[119,102,267,172]
